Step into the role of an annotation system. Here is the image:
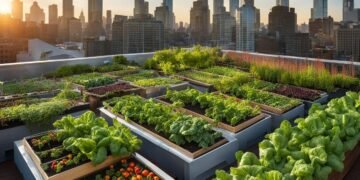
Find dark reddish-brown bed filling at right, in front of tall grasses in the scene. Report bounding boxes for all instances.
[272,85,320,101]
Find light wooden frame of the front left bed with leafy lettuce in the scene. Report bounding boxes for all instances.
[22,133,130,180]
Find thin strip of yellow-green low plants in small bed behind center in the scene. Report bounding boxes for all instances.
[134,77,182,87]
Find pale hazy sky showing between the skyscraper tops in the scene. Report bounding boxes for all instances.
[0,0,360,24]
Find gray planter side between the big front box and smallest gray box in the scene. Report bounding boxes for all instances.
[217,115,272,151]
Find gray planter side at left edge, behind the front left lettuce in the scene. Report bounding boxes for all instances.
[0,110,87,163]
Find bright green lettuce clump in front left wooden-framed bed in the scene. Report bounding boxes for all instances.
[54,112,142,165]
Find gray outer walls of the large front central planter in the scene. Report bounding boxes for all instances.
[100,108,238,180]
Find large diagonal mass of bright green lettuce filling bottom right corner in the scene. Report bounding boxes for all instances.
[216,92,360,180]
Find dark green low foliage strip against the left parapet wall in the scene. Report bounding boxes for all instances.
[46,64,94,78]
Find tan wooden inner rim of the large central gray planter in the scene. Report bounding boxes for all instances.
[108,108,228,159]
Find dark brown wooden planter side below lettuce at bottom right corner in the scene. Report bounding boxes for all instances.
[329,144,360,180]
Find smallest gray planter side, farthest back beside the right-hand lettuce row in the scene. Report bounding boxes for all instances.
[263,104,305,130]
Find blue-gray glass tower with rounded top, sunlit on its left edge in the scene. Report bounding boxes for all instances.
[236,0,256,52]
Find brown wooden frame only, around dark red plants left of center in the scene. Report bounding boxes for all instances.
[83,84,144,110]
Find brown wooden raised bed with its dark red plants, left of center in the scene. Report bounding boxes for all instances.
[84,82,143,110]
